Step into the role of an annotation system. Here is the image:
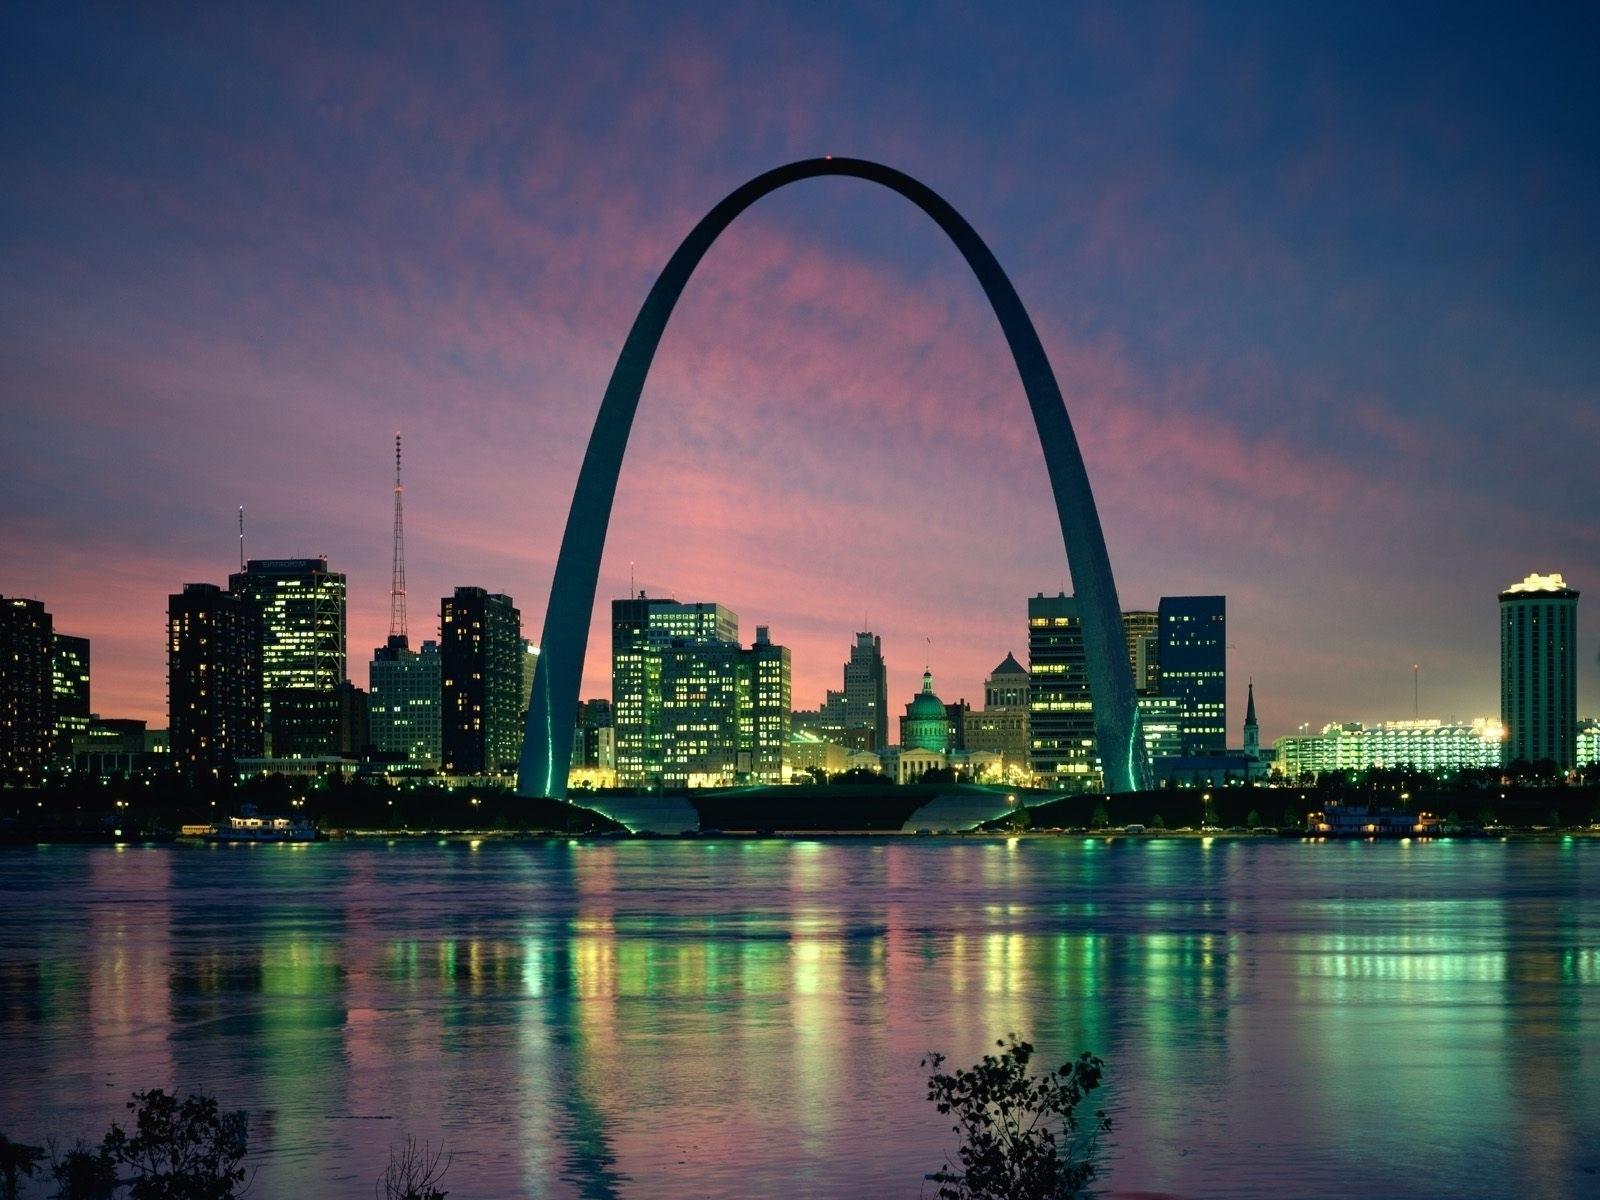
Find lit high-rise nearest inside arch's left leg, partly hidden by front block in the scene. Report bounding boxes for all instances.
[611,592,739,787]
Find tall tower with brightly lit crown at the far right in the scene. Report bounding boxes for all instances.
[1499,574,1578,771]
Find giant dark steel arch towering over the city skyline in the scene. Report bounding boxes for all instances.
[517,157,1147,798]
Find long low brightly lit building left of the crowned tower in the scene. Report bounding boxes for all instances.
[1272,717,1506,782]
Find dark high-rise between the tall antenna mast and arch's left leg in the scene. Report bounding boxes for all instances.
[438,587,526,774]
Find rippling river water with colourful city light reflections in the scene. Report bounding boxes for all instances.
[0,840,1600,1200]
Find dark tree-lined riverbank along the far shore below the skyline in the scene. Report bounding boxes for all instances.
[0,770,1600,843]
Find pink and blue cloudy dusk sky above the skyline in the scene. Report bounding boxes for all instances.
[0,5,1600,739]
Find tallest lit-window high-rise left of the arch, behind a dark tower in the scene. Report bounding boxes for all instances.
[227,558,346,757]
